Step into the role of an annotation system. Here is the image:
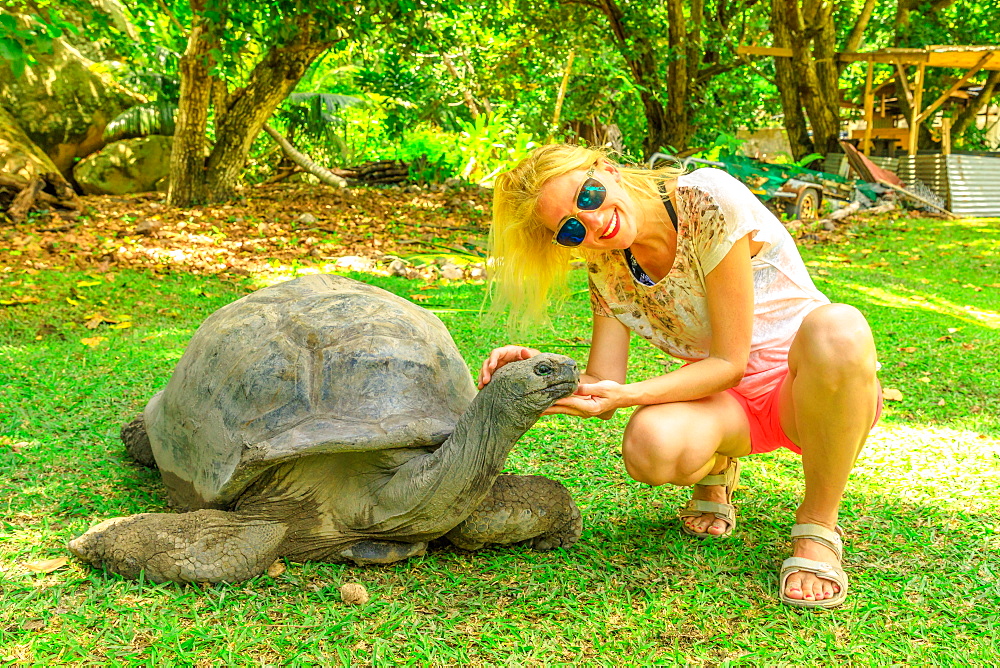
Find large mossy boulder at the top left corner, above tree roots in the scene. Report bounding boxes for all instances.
[0,12,144,176]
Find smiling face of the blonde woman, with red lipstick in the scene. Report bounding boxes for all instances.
[536,162,638,250]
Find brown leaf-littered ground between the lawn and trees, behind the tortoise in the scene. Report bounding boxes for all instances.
[0,184,490,275]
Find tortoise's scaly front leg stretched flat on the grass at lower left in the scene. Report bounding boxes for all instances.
[69,510,286,582]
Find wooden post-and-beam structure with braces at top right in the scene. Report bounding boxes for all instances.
[737,46,1000,155]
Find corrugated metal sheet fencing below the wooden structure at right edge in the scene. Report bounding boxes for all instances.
[896,154,1000,216]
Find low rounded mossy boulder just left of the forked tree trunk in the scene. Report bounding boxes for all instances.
[73,135,173,195]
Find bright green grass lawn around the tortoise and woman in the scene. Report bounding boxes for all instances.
[0,219,1000,666]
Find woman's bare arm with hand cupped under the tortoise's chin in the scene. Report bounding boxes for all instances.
[549,235,753,417]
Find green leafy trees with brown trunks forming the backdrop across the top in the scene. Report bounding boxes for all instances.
[0,0,1000,205]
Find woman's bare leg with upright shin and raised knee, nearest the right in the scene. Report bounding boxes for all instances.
[779,304,878,601]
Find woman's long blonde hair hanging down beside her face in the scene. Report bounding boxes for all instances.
[487,144,684,333]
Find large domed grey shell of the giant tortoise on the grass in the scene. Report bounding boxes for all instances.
[144,275,476,509]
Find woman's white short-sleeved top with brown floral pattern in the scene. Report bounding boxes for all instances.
[584,168,830,397]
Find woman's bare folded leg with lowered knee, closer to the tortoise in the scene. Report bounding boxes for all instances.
[622,393,750,535]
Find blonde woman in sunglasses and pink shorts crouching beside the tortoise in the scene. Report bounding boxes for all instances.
[479,145,881,607]
